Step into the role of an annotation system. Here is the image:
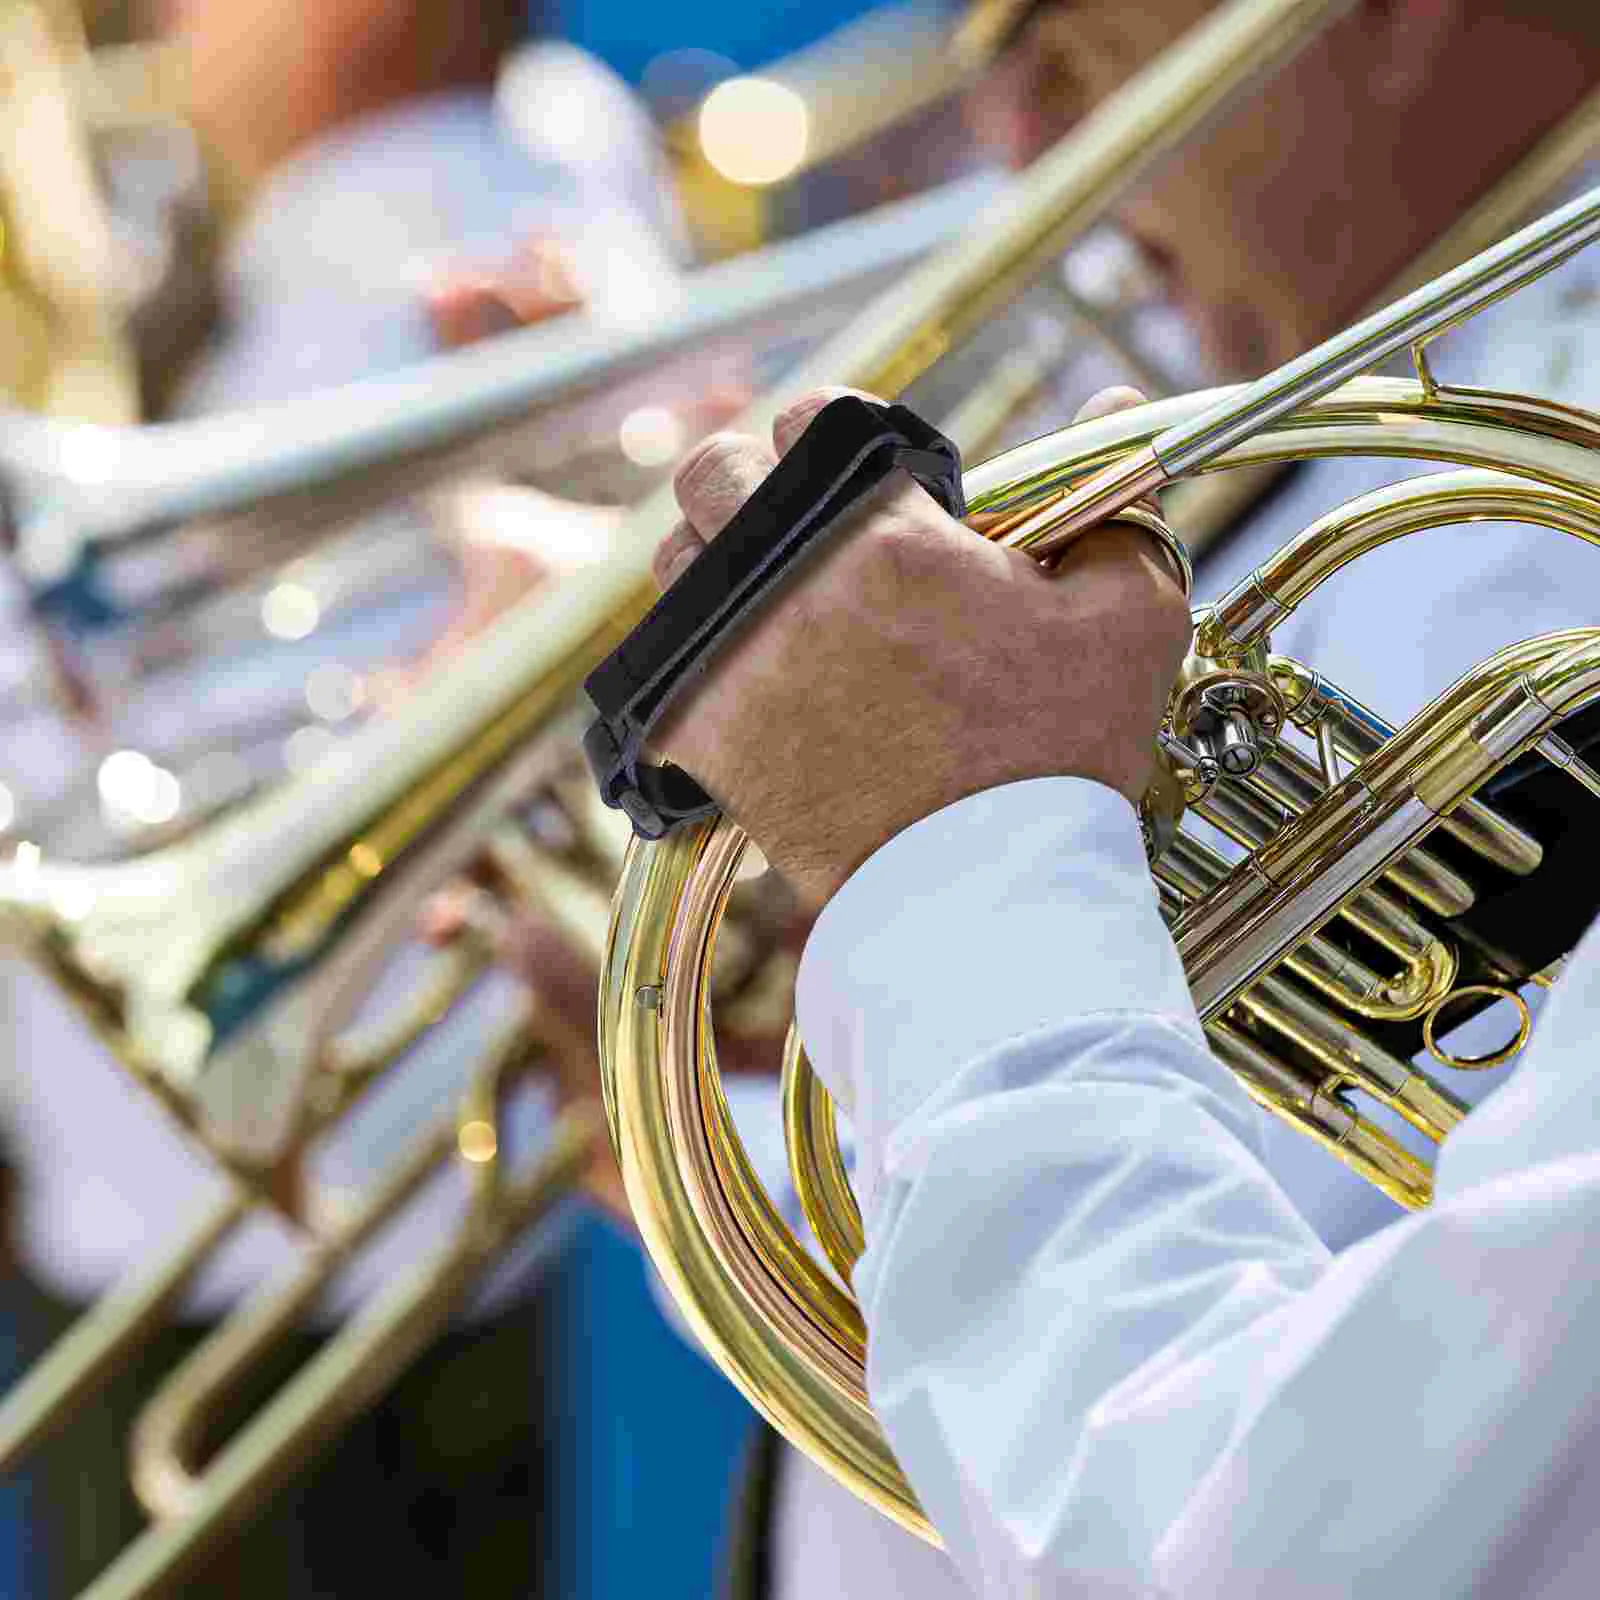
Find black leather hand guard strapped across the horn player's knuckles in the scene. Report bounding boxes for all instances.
[584,395,965,838]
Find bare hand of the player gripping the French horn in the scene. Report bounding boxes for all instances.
[653,390,1190,901]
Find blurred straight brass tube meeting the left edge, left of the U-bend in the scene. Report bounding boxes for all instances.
[0,1184,254,1472]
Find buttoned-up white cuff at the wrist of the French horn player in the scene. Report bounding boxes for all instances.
[795,778,1200,1190]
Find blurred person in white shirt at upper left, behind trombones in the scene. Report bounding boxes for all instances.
[166,0,683,411]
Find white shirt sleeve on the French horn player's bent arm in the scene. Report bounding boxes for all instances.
[798,778,1600,1600]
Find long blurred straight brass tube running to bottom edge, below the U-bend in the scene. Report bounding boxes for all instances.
[78,1110,598,1600]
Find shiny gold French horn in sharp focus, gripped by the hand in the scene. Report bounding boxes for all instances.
[600,144,1600,1539]
